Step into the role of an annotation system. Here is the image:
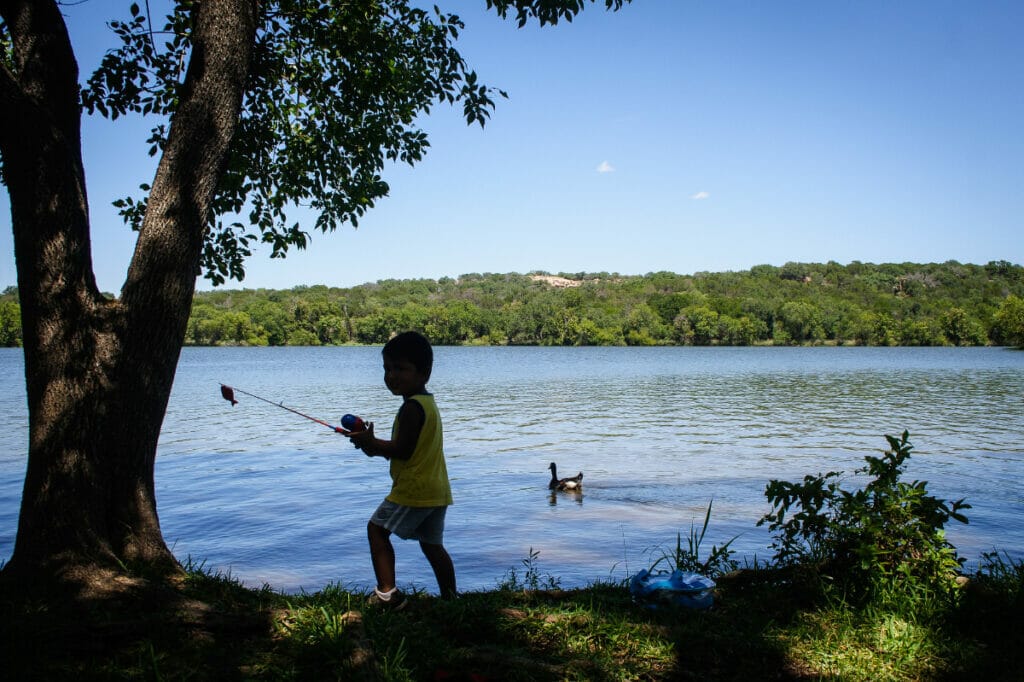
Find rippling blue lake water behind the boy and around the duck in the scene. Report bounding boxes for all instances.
[0,347,1024,593]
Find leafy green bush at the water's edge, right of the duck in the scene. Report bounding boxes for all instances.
[758,431,971,602]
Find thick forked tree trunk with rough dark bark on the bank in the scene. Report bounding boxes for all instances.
[0,0,256,582]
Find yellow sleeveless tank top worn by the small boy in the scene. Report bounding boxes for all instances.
[387,393,452,507]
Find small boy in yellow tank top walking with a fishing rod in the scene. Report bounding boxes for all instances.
[348,332,456,609]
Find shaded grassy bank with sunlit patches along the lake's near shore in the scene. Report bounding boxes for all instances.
[0,552,1024,680]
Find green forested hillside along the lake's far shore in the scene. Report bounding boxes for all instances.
[0,261,1024,346]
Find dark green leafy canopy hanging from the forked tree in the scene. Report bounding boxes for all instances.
[72,0,625,284]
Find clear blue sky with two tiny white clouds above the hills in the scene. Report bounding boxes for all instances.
[0,0,1024,292]
